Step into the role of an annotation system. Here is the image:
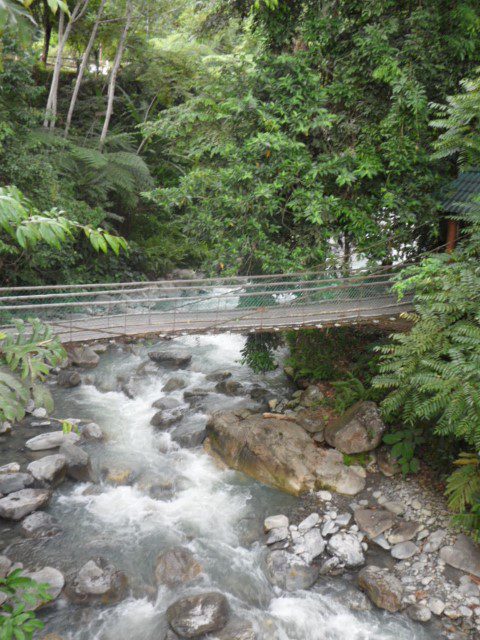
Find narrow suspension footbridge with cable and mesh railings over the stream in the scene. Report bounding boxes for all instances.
[0,265,412,344]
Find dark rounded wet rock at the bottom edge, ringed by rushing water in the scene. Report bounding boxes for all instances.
[167,592,230,638]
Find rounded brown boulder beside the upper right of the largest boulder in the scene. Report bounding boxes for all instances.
[325,402,385,454]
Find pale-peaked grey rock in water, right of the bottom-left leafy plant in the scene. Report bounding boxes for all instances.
[66,558,127,604]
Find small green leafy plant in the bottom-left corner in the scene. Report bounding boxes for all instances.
[0,569,52,640]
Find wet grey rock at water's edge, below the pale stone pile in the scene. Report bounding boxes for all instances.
[265,550,319,591]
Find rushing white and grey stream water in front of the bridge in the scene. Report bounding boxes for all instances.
[1,335,439,640]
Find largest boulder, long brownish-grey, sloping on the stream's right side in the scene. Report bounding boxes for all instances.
[206,412,365,495]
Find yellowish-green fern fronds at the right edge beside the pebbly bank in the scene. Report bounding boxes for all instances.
[445,453,480,542]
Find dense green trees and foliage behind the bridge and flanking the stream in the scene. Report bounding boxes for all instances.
[0,0,480,552]
